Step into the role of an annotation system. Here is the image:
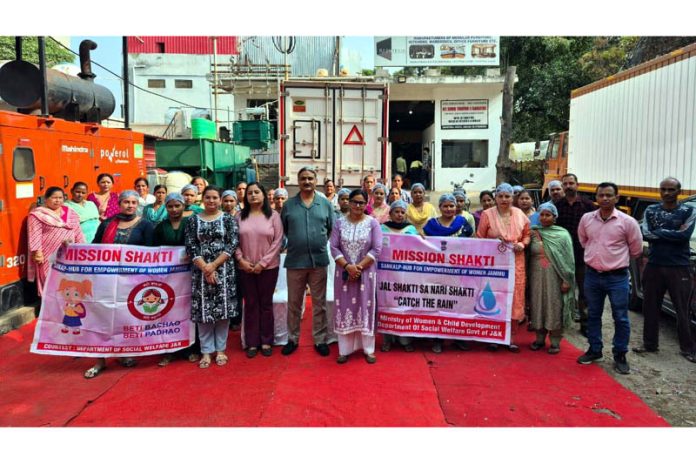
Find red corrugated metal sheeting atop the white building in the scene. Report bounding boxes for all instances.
[128,36,237,55]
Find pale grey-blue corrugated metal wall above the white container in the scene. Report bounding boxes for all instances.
[238,36,336,77]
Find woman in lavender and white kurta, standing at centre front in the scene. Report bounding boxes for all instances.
[330,190,382,364]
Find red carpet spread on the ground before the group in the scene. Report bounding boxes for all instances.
[0,300,668,427]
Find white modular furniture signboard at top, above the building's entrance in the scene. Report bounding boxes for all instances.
[375,36,500,66]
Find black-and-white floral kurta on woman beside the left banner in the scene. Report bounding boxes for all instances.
[184,213,239,323]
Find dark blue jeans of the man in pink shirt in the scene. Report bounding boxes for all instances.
[585,267,631,355]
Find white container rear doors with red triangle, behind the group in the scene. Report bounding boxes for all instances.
[279,79,391,190]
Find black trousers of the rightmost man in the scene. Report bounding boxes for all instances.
[642,264,696,353]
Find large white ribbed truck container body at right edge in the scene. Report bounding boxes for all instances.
[567,40,696,218]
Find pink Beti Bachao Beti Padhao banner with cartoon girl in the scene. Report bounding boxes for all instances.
[31,245,195,357]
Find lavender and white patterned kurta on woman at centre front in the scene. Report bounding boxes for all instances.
[330,216,382,335]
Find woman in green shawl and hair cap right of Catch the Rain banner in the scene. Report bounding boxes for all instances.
[529,202,576,354]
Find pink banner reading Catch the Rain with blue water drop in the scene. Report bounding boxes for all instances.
[377,234,515,344]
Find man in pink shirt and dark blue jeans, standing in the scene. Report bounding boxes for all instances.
[578,182,643,374]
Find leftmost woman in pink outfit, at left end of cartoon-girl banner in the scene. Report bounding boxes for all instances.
[27,187,85,296]
